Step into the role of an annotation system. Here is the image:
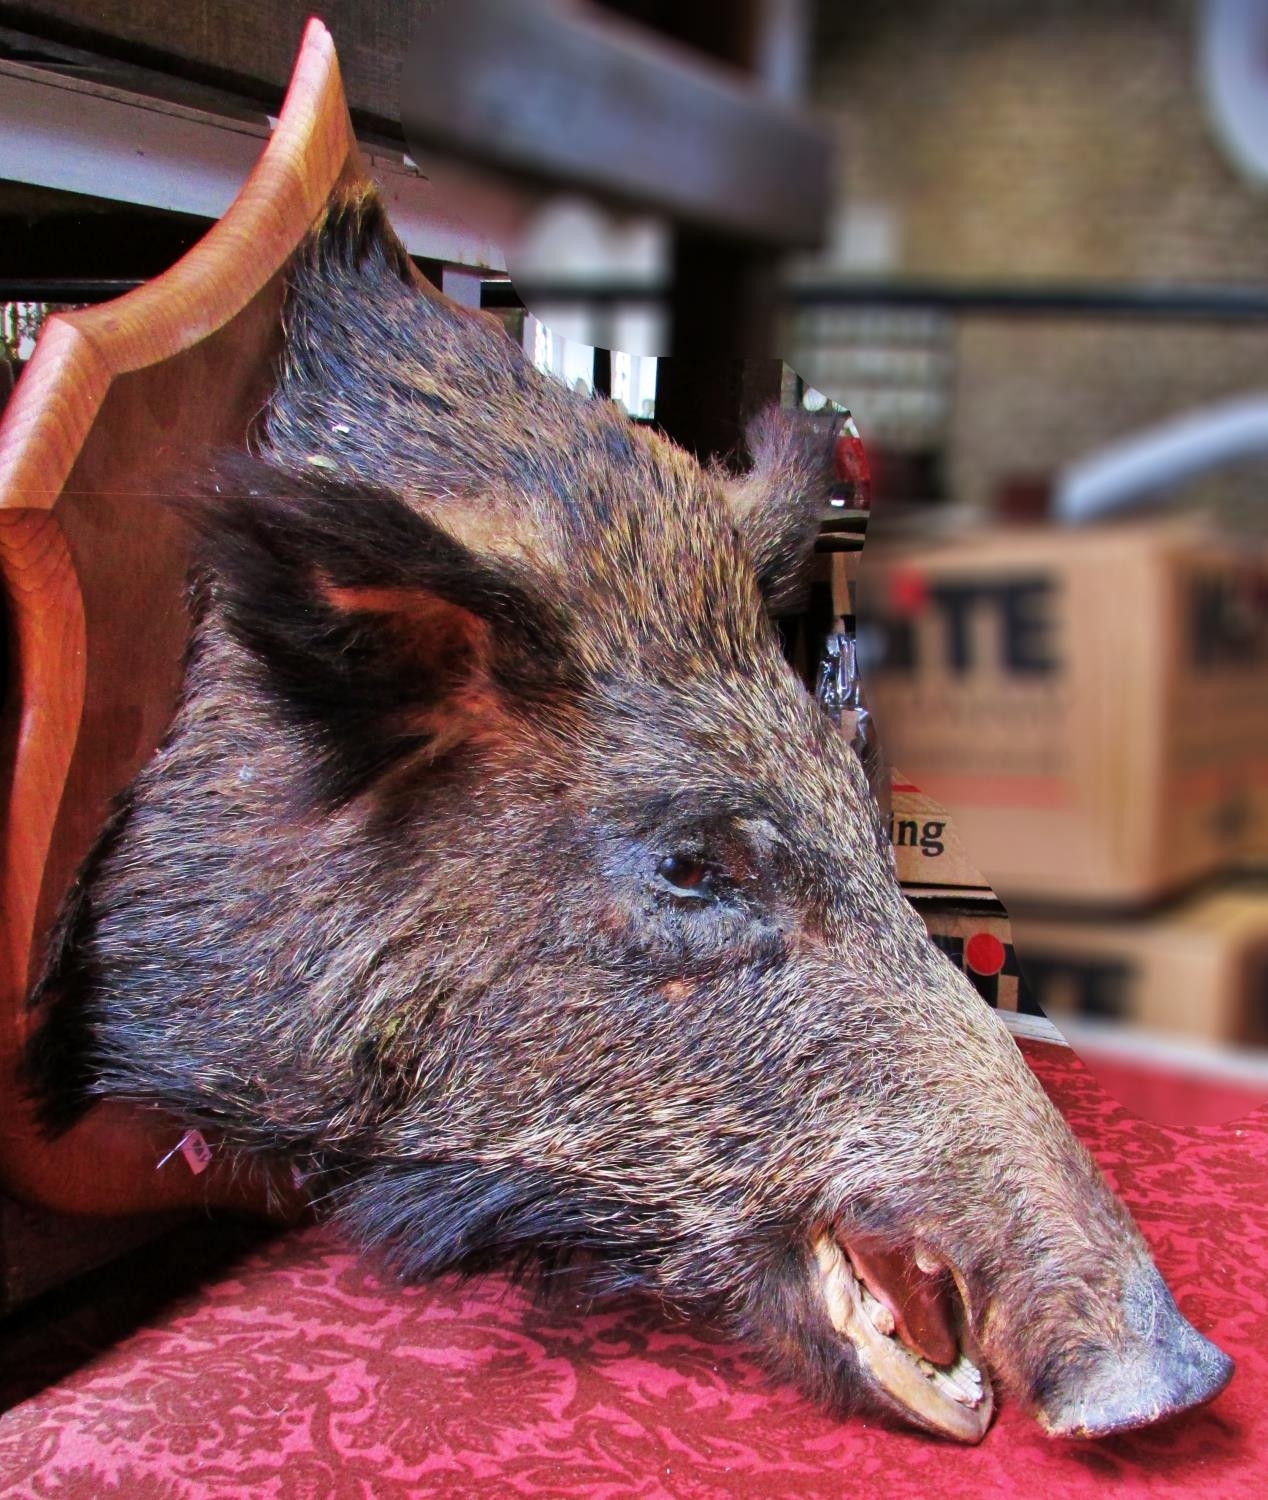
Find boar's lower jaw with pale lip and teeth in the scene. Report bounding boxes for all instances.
[813,1233,995,1443]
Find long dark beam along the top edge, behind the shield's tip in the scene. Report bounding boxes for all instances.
[0,0,830,248]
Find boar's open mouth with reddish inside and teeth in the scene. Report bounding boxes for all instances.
[813,1232,995,1443]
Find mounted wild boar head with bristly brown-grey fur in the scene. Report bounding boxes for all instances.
[29,195,1227,1436]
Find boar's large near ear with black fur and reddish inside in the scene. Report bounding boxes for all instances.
[186,461,573,803]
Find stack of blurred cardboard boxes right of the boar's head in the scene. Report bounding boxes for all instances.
[834,521,1268,1074]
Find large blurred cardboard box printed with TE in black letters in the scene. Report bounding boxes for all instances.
[860,522,1268,906]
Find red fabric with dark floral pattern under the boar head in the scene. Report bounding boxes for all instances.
[0,1047,1268,1500]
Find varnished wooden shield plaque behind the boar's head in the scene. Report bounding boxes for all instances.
[0,21,365,1214]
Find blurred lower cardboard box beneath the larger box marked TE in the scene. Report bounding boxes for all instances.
[1013,884,1268,1058]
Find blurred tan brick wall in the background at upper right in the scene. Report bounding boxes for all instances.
[813,0,1268,509]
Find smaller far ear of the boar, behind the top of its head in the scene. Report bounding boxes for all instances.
[726,407,837,614]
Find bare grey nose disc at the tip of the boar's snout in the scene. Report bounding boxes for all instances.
[1040,1266,1233,1437]
